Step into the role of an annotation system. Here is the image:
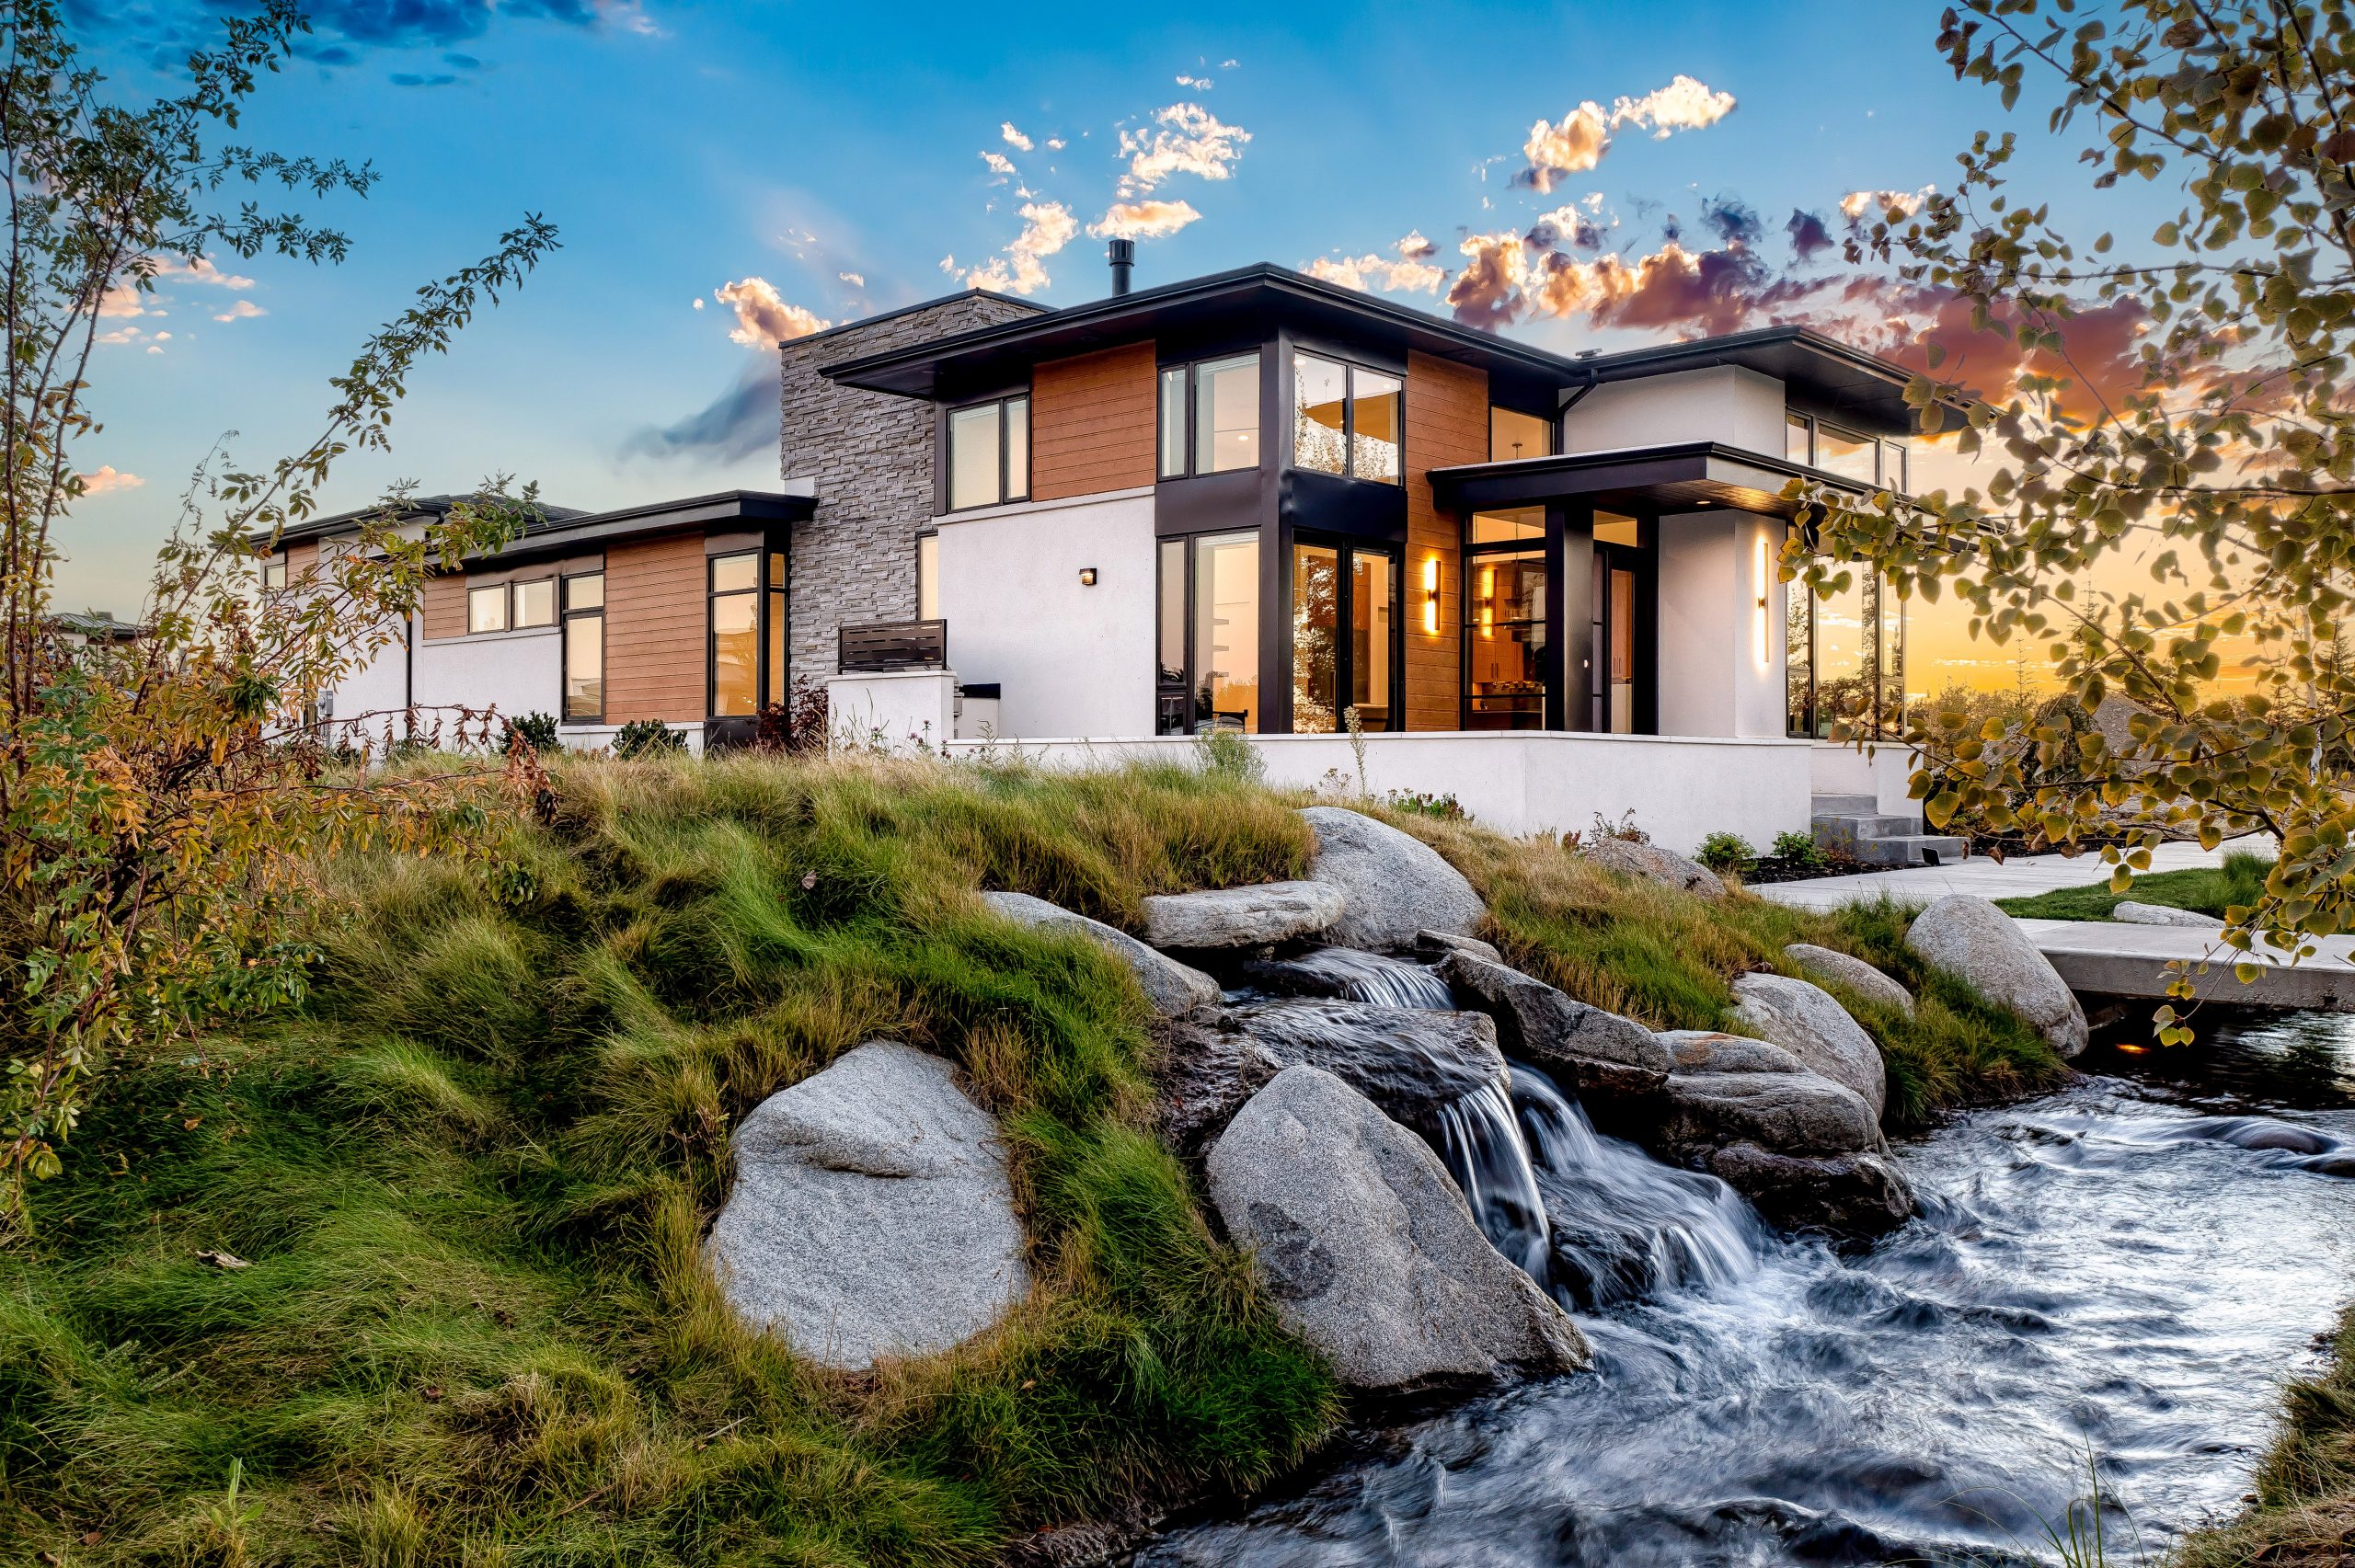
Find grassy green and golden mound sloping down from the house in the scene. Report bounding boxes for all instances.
[0,761,2058,1568]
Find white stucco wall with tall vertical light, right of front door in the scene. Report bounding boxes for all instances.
[1660,511,1785,739]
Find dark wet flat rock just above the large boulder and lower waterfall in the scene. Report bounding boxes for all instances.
[1234,998,1510,1132]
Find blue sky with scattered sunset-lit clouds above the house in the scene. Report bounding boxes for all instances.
[59,0,2156,612]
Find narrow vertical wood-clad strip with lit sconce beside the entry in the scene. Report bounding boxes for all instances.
[1406,353,1488,730]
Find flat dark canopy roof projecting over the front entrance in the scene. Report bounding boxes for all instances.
[1431,441,1872,518]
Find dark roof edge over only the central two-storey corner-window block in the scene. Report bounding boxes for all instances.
[820,261,1580,398]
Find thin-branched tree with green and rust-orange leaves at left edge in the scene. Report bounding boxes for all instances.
[0,0,556,1231]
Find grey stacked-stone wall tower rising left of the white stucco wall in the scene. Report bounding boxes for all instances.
[777,290,1036,681]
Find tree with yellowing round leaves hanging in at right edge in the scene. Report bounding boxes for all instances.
[1783,0,2355,1041]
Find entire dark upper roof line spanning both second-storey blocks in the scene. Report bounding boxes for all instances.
[824,261,1959,433]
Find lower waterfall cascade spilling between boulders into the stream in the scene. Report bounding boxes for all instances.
[1498,1062,1766,1311]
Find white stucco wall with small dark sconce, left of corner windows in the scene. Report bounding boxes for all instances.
[935,489,1156,737]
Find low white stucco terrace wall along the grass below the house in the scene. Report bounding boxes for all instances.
[949,730,1813,854]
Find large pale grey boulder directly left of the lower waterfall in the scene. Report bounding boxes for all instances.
[1206,1067,1587,1396]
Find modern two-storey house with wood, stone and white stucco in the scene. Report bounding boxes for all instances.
[270,243,1936,854]
